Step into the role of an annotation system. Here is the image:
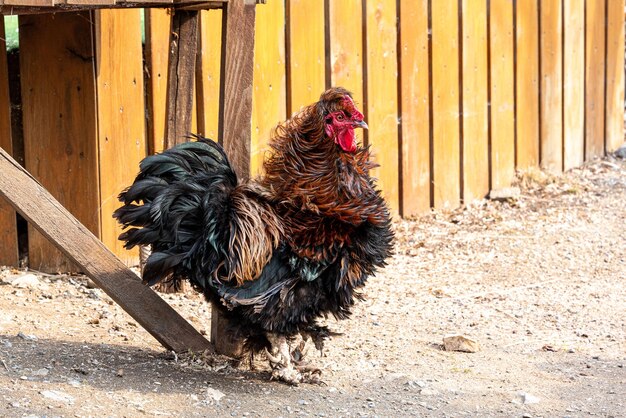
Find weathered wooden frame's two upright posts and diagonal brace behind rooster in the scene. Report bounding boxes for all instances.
[0,0,264,355]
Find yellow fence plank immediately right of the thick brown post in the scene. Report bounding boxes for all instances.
[251,1,286,174]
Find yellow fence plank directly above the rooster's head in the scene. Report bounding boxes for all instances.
[327,0,363,105]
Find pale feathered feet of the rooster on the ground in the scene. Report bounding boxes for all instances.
[265,333,322,385]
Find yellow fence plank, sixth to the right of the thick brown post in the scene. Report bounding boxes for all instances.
[431,0,460,208]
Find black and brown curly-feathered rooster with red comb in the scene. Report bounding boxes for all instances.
[113,88,393,384]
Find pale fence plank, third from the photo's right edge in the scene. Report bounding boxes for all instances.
[563,0,584,170]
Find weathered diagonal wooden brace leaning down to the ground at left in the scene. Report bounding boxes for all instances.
[0,149,210,352]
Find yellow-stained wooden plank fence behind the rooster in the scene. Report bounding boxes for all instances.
[0,0,624,270]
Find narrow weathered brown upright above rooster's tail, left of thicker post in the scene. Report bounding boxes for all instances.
[165,10,199,148]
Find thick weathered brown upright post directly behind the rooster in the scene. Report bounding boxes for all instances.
[211,0,255,357]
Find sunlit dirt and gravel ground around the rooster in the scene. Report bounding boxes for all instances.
[0,158,626,417]
